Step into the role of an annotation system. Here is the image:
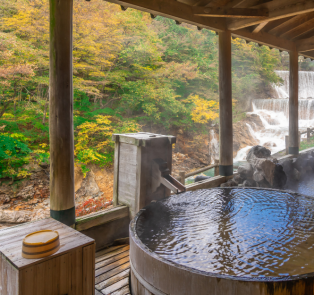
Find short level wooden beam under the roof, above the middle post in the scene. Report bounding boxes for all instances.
[193,7,268,19]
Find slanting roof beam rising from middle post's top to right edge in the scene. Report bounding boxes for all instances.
[228,0,314,30]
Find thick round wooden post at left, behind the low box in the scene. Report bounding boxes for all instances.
[49,0,75,226]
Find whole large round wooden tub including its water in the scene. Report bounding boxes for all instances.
[130,188,314,295]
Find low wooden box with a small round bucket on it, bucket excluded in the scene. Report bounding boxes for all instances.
[0,218,95,295]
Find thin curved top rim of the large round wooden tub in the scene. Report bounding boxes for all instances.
[129,187,314,283]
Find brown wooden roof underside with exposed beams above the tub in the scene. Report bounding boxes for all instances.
[108,0,314,59]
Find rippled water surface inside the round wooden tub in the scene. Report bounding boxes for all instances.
[137,188,314,277]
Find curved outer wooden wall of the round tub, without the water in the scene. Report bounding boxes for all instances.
[130,190,314,295]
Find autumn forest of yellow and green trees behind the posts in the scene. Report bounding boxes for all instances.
[0,0,312,179]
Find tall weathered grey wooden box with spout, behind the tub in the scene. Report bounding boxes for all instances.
[113,132,176,219]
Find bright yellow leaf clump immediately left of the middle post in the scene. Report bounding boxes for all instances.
[190,95,219,124]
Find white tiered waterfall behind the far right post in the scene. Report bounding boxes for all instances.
[234,71,314,162]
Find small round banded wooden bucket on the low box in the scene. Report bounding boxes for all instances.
[22,230,60,259]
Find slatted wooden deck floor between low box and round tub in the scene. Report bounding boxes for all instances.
[95,245,130,295]
